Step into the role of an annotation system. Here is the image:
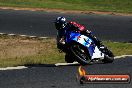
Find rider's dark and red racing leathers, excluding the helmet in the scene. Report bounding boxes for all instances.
[55,22,100,52]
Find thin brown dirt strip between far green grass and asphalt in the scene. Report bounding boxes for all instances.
[0,7,132,16]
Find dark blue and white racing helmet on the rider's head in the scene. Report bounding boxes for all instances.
[55,17,66,30]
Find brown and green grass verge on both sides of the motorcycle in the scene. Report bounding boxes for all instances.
[0,35,132,67]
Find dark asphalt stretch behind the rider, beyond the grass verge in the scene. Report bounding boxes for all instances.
[0,10,132,42]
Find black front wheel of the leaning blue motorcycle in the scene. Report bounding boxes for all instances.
[70,43,91,65]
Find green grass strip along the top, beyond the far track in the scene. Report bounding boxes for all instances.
[0,0,132,13]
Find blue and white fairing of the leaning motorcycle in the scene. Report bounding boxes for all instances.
[66,32,104,59]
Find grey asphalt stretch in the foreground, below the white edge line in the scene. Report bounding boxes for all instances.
[0,57,132,88]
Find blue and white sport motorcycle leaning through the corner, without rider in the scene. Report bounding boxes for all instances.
[59,30,114,65]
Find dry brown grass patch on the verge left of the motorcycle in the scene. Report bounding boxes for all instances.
[0,36,55,59]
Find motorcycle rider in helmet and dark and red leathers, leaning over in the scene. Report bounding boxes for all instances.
[55,17,100,51]
